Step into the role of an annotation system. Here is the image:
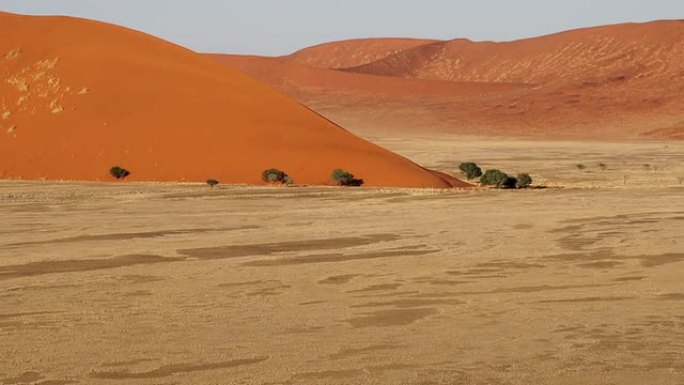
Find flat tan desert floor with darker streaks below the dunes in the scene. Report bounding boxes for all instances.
[0,137,684,385]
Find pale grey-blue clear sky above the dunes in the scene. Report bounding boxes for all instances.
[0,0,684,55]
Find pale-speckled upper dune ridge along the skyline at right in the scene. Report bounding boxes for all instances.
[348,20,684,83]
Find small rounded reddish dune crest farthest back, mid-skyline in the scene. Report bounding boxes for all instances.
[289,38,437,68]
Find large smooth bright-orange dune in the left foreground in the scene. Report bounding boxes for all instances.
[0,13,470,187]
